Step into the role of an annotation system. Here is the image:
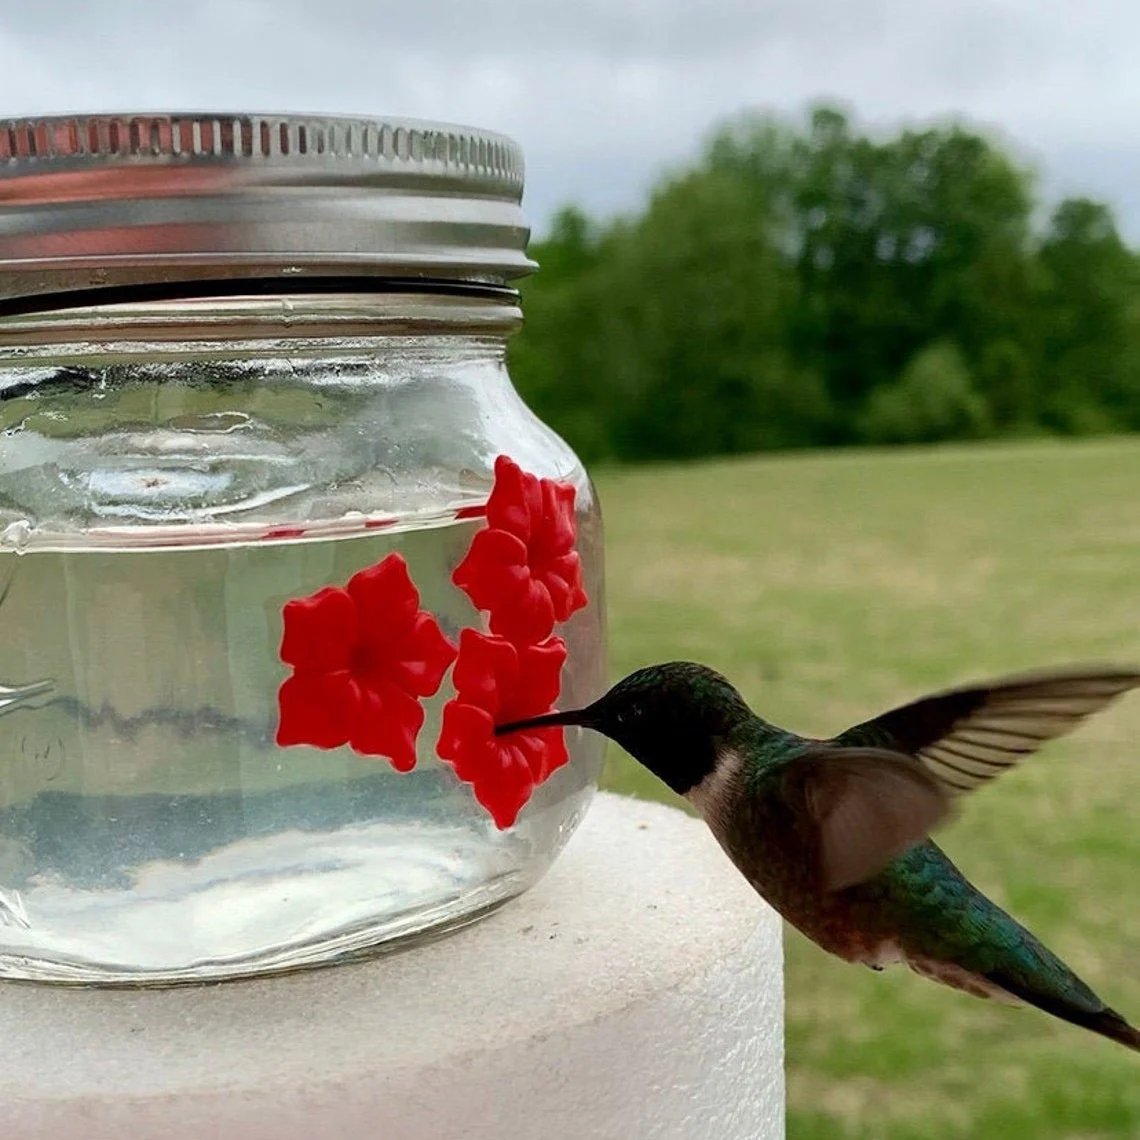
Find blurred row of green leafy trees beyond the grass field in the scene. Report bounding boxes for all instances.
[511,107,1140,461]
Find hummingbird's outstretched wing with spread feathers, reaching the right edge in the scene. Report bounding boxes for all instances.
[832,668,1140,795]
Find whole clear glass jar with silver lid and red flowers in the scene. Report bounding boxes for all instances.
[0,115,605,984]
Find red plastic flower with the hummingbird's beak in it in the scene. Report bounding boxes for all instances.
[437,629,569,829]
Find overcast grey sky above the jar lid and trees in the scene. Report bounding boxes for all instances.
[0,0,1140,241]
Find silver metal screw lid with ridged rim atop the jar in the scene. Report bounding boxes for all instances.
[0,114,535,299]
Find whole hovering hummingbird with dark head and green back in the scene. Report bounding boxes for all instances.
[495,661,1140,1051]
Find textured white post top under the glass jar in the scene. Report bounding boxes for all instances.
[0,795,783,1140]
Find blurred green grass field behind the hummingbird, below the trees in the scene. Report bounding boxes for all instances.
[597,439,1140,1140]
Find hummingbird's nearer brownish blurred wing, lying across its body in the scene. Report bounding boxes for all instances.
[782,743,950,890]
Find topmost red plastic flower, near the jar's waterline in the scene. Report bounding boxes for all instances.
[451,455,587,645]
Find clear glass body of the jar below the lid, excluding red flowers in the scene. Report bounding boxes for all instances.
[0,293,605,983]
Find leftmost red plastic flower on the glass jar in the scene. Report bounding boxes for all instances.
[277,554,455,772]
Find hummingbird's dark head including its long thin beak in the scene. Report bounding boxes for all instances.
[495,661,751,796]
